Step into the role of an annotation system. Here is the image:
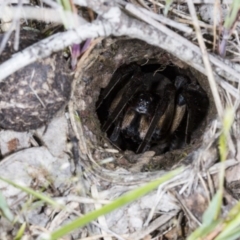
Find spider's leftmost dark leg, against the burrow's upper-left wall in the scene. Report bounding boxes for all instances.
[96,64,140,109]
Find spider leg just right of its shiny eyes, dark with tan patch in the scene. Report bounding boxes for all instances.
[137,84,175,153]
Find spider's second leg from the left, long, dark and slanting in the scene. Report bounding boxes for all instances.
[102,72,145,132]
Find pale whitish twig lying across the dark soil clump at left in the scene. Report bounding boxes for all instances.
[0,20,112,80]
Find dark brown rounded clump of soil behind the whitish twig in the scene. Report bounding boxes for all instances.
[0,30,73,131]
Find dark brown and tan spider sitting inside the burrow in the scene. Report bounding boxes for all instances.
[97,64,208,153]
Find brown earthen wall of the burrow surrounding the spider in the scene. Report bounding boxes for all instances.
[74,38,216,171]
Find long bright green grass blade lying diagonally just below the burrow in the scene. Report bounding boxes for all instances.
[47,168,184,240]
